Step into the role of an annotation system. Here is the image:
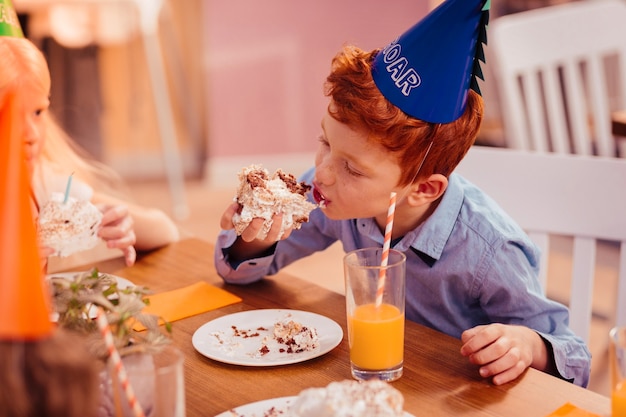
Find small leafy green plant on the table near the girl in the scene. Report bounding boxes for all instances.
[50,269,171,358]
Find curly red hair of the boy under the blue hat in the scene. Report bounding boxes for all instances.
[325,46,483,186]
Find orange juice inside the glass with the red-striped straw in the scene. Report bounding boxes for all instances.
[348,304,404,370]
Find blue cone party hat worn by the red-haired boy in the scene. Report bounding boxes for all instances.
[372,0,491,123]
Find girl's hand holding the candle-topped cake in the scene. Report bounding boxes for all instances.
[98,204,137,266]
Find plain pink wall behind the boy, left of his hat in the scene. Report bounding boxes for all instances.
[204,0,428,162]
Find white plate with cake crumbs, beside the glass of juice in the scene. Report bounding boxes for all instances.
[191,309,343,366]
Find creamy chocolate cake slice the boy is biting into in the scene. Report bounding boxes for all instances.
[233,165,316,239]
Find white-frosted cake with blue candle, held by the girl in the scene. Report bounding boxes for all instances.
[39,193,102,257]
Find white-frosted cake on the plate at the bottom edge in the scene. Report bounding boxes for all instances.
[285,379,404,417]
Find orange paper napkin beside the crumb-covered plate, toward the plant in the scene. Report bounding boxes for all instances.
[135,281,241,330]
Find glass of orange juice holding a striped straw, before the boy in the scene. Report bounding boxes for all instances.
[343,248,406,381]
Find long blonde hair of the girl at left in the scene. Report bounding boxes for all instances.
[0,36,124,195]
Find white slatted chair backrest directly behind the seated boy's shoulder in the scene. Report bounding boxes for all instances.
[456,146,626,341]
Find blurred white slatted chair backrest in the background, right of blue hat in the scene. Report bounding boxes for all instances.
[487,0,626,156]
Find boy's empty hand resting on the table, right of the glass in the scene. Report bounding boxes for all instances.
[461,323,547,385]
